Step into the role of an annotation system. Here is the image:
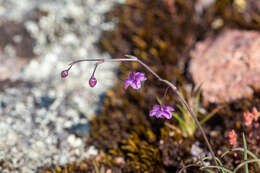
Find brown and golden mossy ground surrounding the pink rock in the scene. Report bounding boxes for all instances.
[38,0,260,173]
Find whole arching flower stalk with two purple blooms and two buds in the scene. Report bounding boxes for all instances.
[61,55,218,165]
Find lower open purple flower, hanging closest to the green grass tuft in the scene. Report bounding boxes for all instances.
[150,105,174,119]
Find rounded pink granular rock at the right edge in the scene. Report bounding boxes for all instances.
[189,30,260,103]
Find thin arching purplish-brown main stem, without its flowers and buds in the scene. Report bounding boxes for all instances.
[64,55,218,168]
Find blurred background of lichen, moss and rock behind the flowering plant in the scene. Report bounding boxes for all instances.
[0,0,260,173]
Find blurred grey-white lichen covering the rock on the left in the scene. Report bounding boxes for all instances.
[0,0,125,173]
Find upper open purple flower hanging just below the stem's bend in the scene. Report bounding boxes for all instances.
[125,72,147,90]
